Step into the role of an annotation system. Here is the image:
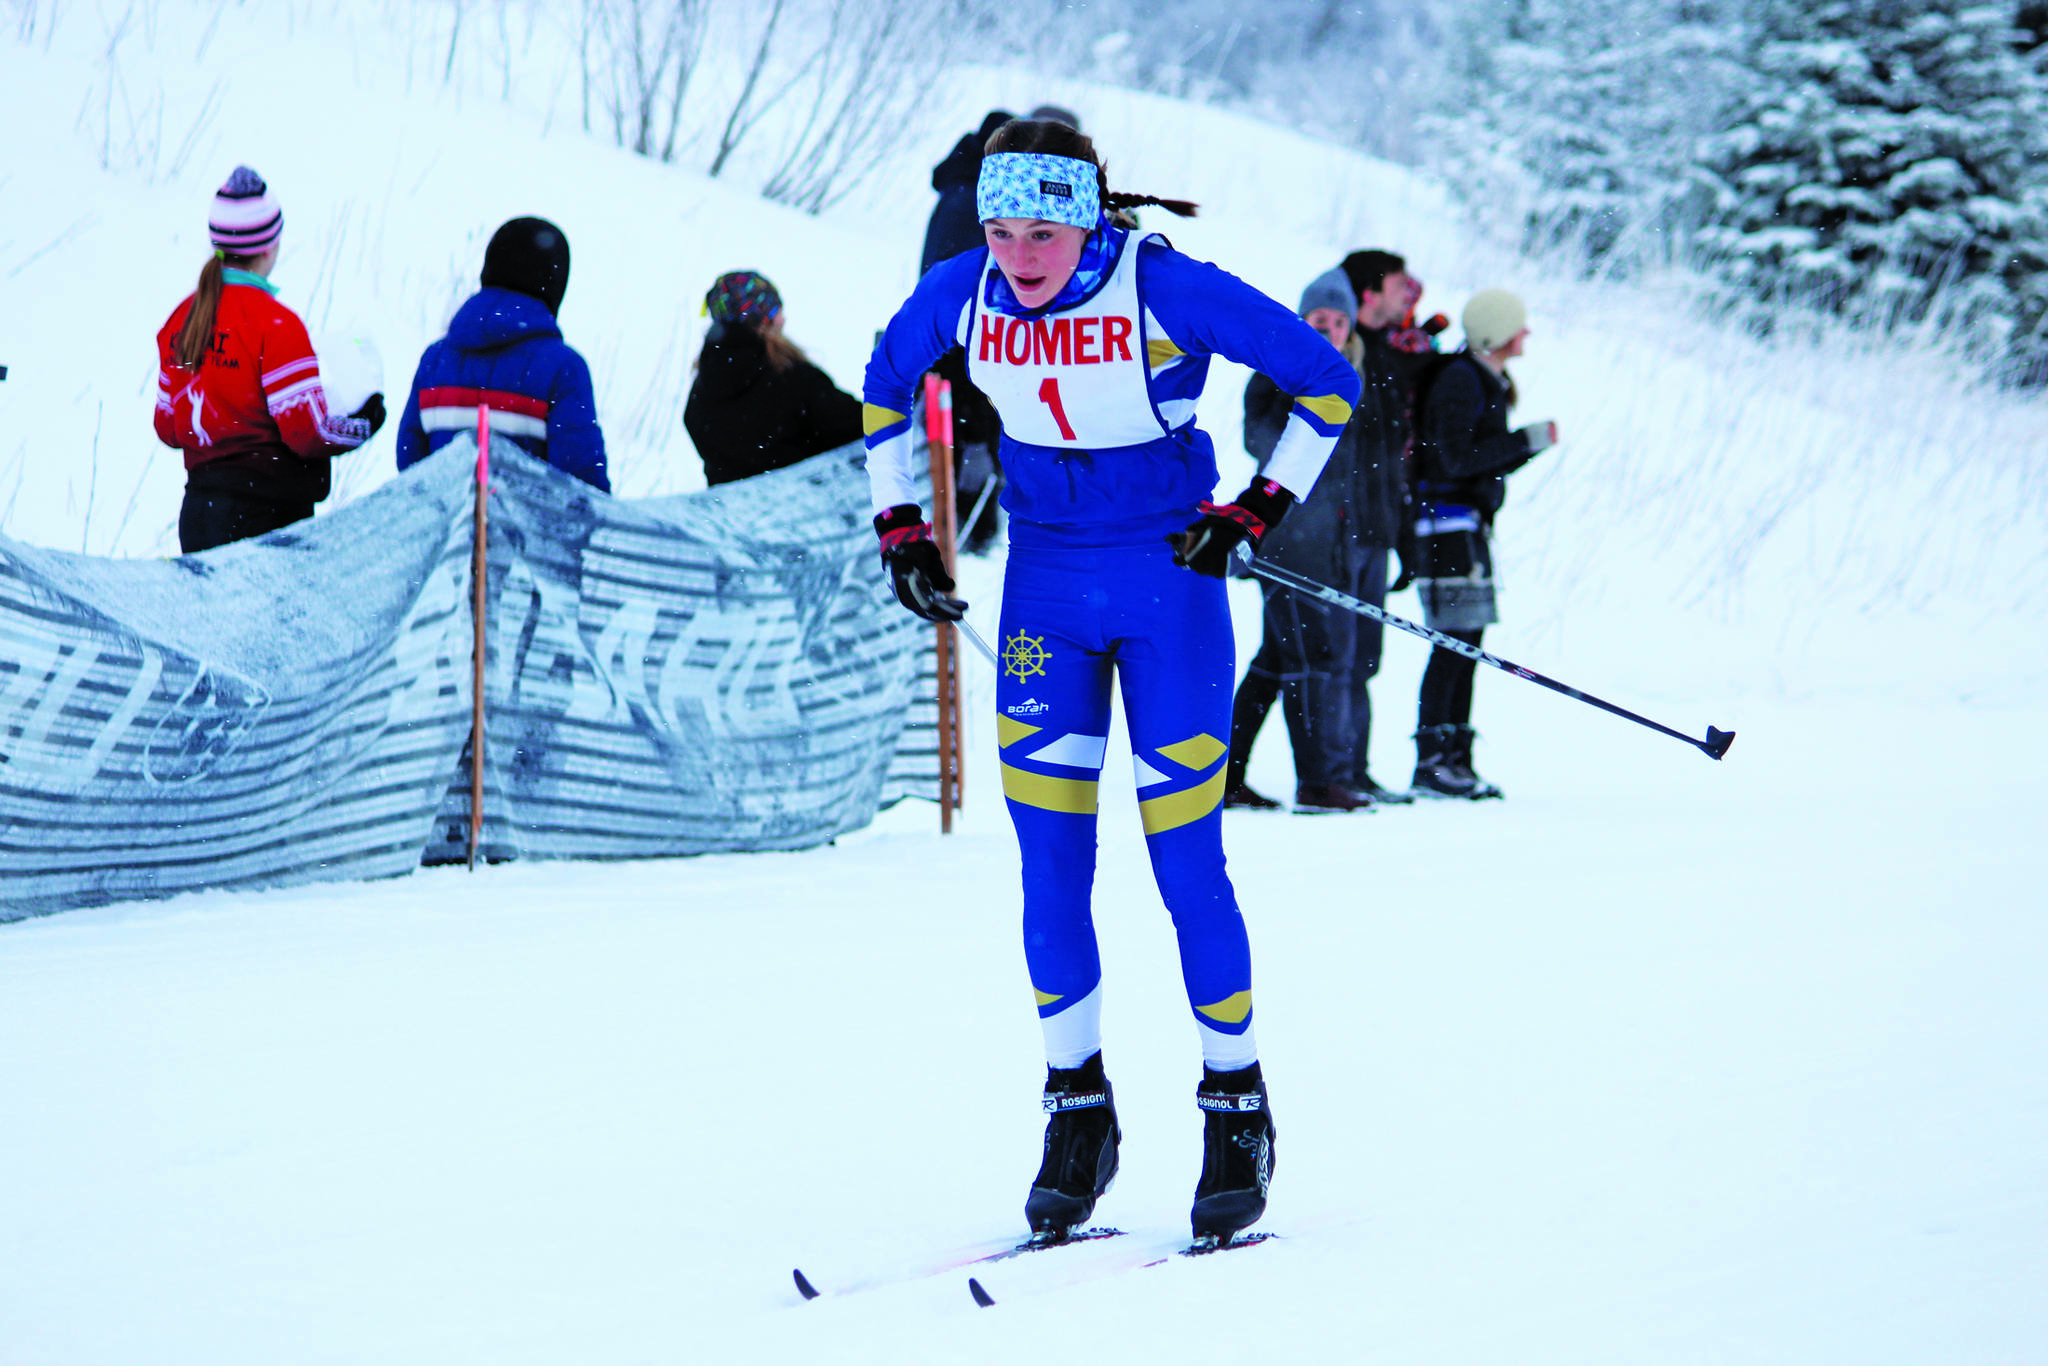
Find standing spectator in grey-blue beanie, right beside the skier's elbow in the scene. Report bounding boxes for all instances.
[1223,270,1386,815]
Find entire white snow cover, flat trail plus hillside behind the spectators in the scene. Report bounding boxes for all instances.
[0,0,2048,1366]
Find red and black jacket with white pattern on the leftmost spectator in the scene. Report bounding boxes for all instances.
[156,270,371,502]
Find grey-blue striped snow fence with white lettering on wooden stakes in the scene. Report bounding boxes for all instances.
[0,438,936,920]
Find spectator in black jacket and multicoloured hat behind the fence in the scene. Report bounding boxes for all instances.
[682,270,862,483]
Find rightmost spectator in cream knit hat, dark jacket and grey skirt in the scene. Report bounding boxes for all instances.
[1415,289,1556,799]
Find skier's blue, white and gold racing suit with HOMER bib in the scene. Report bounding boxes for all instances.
[864,225,1358,1071]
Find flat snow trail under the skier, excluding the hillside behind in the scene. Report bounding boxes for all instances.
[0,622,2048,1366]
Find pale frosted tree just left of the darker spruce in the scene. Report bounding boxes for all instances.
[1430,0,1755,270]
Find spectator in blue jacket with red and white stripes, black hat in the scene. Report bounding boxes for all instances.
[397,219,612,494]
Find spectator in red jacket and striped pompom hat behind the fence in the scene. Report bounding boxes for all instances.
[156,166,385,555]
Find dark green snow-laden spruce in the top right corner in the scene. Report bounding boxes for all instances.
[1700,0,2048,383]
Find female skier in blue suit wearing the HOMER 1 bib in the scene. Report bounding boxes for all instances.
[864,121,1358,1241]
